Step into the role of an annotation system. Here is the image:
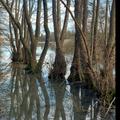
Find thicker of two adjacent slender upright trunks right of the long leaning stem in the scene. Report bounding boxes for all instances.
[93,0,100,60]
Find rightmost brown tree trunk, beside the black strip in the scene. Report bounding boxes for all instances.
[102,0,116,90]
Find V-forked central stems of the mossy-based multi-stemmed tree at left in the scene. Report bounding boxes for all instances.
[24,0,41,70]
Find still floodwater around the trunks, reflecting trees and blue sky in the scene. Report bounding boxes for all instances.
[0,43,115,120]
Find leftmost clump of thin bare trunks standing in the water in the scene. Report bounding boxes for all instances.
[6,0,23,62]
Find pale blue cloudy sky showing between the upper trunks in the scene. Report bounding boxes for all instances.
[0,0,111,37]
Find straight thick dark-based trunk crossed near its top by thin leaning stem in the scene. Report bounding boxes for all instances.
[68,0,82,82]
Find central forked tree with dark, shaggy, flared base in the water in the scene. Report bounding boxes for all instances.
[49,0,70,79]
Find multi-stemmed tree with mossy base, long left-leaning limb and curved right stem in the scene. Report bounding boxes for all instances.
[1,0,49,72]
